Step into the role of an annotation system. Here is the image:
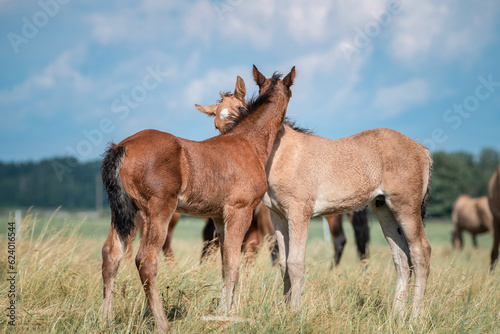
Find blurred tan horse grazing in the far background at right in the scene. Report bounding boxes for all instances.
[451,195,493,250]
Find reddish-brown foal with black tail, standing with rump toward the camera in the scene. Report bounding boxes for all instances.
[102,68,295,332]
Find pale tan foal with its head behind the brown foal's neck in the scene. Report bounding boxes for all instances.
[196,66,432,317]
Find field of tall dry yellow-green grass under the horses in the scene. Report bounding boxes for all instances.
[0,207,500,333]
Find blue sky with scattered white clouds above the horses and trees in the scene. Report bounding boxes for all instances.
[0,0,500,161]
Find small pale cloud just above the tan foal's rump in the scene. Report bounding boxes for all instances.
[372,79,429,119]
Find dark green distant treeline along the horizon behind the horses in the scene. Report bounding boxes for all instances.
[0,149,500,217]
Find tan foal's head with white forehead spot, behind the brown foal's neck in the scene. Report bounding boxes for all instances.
[195,76,246,133]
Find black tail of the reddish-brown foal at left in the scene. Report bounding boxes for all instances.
[101,143,137,240]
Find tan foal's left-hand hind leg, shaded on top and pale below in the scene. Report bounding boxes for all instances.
[371,204,411,318]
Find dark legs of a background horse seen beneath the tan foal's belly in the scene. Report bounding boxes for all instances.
[325,208,370,269]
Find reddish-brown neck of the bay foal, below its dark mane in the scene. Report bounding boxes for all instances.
[232,96,286,165]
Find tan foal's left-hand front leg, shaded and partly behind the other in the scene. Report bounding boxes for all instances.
[271,211,292,302]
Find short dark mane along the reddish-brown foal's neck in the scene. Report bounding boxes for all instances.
[221,72,282,133]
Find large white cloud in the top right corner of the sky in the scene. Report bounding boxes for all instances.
[388,0,500,65]
